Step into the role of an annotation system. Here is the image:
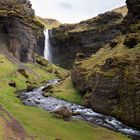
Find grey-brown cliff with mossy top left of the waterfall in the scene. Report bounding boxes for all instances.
[0,0,45,62]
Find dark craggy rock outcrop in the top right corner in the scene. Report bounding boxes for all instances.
[122,0,140,48]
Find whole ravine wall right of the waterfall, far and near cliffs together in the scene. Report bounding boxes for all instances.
[50,0,140,128]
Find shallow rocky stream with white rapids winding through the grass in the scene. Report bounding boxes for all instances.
[20,79,140,139]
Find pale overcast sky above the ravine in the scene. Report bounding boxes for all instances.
[30,0,125,23]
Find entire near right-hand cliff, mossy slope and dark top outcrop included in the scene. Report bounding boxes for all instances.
[72,0,140,127]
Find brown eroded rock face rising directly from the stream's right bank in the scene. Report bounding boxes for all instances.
[72,54,140,127]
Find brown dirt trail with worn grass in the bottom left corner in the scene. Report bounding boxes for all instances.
[0,105,34,140]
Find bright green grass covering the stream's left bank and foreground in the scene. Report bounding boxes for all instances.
[0,55,128,140]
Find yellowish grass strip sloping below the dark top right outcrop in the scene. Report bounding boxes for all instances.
[77,36,140,74]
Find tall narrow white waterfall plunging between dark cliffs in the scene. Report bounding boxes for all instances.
[44,29,51,62]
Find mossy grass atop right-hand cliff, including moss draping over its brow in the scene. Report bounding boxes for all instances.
[79,36,140,78]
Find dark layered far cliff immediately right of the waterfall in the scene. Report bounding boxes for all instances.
[50,11,123,68]
